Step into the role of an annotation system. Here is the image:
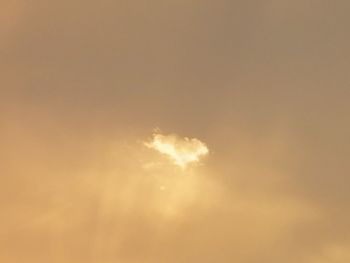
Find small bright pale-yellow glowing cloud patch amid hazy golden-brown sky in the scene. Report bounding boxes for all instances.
[145,133,209,168]
